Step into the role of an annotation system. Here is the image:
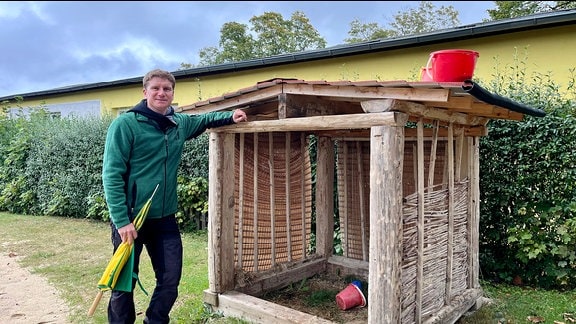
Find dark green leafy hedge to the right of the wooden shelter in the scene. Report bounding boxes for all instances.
[480,48,576,288]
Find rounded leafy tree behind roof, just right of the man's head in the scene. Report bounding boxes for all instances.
[196,11,326,67]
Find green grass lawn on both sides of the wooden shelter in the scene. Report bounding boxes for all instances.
[0,213,576,324]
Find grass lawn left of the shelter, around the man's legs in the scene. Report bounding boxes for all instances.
[0,213,210,323]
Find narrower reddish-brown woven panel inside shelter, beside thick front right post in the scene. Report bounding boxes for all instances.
[336,141,370,261]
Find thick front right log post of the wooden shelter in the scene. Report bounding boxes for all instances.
[368,113,407,324]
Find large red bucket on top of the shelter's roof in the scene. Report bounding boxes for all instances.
[426,49,480,82]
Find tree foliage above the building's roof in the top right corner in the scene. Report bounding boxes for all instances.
[487,1,576,20]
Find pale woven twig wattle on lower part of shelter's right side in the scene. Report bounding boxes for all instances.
[401,181,468,323]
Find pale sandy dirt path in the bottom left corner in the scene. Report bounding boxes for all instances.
[0,253,70,324]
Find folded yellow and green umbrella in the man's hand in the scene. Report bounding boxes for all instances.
[88,184,159,316]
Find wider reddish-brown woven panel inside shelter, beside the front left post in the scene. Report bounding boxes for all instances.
[234,132,312,272]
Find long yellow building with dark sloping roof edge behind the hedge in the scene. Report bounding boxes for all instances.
[0,9,576,116]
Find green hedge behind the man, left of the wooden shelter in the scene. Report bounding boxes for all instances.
[0,106,208,230]
